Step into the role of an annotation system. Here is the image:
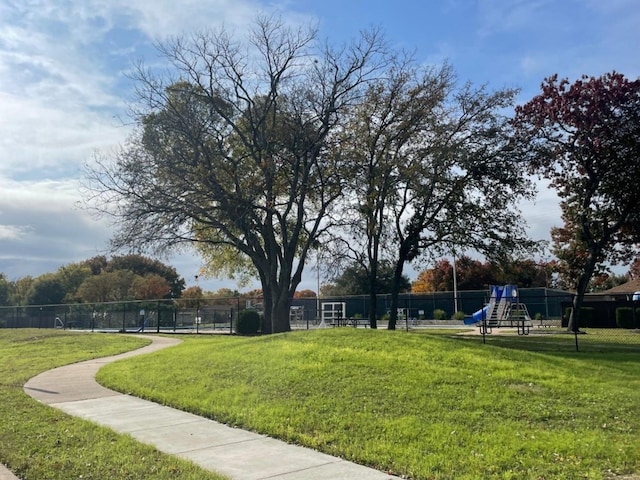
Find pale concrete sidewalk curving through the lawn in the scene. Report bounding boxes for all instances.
[23,336,399,480]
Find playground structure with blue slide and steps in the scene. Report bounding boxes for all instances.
[464,285,532,335]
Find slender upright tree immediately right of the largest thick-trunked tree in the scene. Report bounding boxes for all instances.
[333,58,452,328]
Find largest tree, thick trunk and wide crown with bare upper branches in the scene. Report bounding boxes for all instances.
[88,18,387,332]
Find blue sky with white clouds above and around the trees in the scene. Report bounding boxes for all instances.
[0,0,640,290]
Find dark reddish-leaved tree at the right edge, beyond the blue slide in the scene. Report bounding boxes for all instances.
[514,72,640,331]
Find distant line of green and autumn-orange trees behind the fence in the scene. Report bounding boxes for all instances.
[0,255,640,306]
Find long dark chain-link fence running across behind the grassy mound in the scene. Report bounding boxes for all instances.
[0,288,640,353]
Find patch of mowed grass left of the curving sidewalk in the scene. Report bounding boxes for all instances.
[0,329,229,480]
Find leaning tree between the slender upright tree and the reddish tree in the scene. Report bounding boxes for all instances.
[389,83,535,329]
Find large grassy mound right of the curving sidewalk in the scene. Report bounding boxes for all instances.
[99,328,640,479]
